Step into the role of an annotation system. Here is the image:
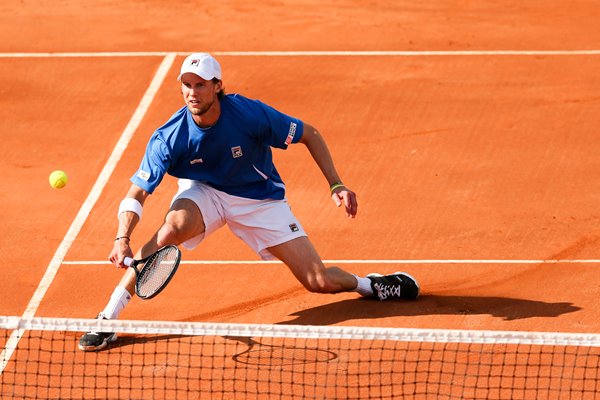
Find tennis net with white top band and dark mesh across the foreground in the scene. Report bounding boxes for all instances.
[0,317,600,400]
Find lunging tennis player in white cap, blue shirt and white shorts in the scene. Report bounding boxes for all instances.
[79,53,419,351]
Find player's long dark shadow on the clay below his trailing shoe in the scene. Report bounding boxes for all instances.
[281,295,581,325]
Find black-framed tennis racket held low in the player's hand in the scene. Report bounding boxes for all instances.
[124,245,181,300]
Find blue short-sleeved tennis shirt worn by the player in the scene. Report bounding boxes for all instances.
[131,94,304,200]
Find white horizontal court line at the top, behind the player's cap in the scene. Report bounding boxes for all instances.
[0,50,600,58]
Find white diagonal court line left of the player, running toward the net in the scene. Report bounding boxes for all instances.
[0,54,175,375]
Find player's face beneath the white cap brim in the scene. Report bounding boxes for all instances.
[181,72,221,117]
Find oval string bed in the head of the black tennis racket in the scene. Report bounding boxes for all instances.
[137,247,179,297]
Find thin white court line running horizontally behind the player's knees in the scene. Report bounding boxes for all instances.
[63,259,600,265]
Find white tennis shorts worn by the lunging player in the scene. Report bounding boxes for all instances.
[171,179,306,260]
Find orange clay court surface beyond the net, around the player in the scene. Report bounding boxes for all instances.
[0,0,600,333]
